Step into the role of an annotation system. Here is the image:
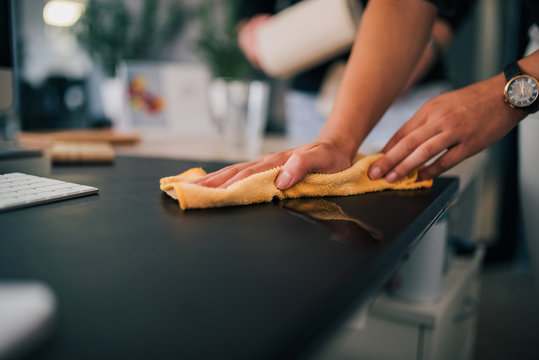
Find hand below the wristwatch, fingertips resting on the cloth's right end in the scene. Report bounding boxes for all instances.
[369,74,526,182]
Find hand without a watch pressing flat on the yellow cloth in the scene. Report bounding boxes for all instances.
[193,142,351,190]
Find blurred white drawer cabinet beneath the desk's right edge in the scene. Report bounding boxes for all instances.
[316,251,482,360]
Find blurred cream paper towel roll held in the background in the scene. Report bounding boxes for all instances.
[257,0,362,77]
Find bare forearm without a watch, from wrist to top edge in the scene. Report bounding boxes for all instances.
[318,0,436,157]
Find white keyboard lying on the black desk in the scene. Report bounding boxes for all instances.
[0,173,99,211]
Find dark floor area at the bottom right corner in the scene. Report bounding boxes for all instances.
[475,264,539,360]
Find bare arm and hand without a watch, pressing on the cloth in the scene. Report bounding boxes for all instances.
[197,0,436,189]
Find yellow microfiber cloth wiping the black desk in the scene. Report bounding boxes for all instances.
[161,154,432,210]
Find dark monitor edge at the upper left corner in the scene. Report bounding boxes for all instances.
[0,0,15,114]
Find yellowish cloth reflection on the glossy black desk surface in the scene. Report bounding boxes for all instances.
[280,198,384,245]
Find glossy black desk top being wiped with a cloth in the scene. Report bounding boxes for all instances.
[0,158,458,359]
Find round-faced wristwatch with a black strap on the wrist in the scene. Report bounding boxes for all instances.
[503,63,539,114]
